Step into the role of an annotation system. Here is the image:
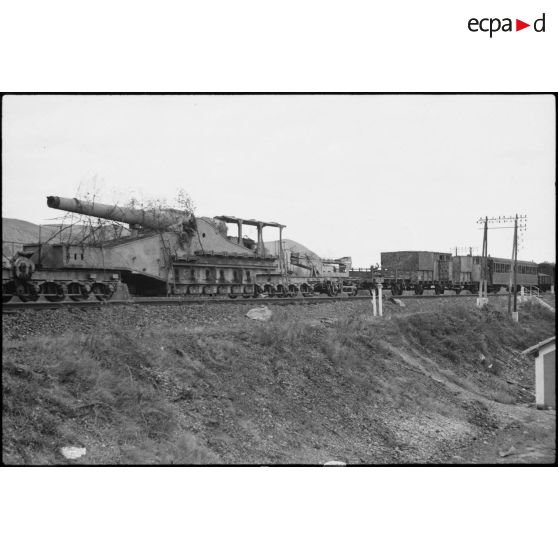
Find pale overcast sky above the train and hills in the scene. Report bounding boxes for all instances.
[2,95,556,267]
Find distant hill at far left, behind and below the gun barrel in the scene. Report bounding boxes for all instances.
[2,218,130,257]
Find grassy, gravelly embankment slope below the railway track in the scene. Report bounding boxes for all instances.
[3,305,554,464]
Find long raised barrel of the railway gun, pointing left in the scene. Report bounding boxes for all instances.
[47,196,195,230]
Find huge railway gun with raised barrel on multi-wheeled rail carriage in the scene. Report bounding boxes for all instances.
[2,196,354,302]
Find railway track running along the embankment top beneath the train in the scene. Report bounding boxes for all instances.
[2,293,508,314]
